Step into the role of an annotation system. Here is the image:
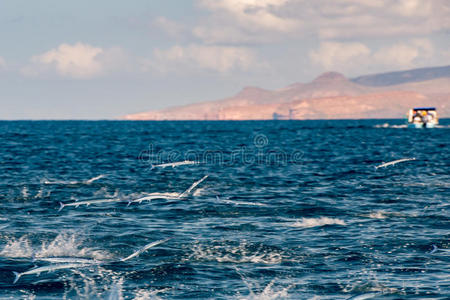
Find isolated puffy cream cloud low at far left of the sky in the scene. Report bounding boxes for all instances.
[22,43,126,79]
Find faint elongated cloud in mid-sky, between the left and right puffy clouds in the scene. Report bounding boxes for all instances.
[148,45,258,73]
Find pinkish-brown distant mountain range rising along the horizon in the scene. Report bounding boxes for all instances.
[123,66,450,120]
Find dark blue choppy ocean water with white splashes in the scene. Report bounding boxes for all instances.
[0,120,450,299]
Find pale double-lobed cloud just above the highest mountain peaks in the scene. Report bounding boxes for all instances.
[310,39,435,73]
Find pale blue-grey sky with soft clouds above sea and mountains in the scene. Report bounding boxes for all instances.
[0,0,450,120]
